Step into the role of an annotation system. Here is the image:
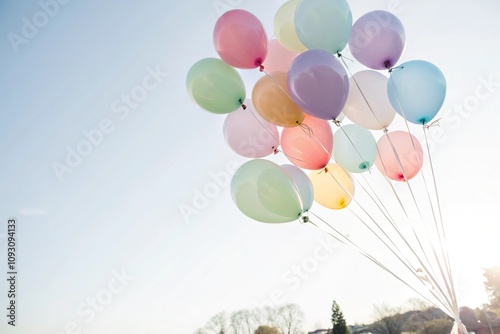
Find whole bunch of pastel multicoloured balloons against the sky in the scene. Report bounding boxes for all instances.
[186,0,446,223]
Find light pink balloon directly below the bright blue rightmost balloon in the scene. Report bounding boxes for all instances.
[375,131,424,182]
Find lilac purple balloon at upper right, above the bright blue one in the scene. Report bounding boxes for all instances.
[349,10,405,70]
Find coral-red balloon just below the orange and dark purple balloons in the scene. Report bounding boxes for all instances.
[281,115,333,170]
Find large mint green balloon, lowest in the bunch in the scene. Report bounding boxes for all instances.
[231,159,302,223]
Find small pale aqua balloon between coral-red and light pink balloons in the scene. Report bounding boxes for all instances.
[333,124,377,173]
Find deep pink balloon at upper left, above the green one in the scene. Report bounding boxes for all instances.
[213,9,267,69]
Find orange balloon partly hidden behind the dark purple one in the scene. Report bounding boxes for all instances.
[252,72,305,127]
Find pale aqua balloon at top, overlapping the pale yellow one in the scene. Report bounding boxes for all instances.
[294,0,352,54]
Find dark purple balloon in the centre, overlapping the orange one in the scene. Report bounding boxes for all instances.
[288,49,349,120]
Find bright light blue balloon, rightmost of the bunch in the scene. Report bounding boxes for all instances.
[387,60,446,124]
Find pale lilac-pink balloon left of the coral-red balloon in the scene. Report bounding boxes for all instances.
[223,99,279,158]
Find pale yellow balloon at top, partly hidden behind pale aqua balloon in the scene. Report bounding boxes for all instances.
[274,0,307,53]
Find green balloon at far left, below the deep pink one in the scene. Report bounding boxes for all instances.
[186,58,246,114]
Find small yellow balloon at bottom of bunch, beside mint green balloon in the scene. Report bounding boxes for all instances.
[309,163,354,210]
